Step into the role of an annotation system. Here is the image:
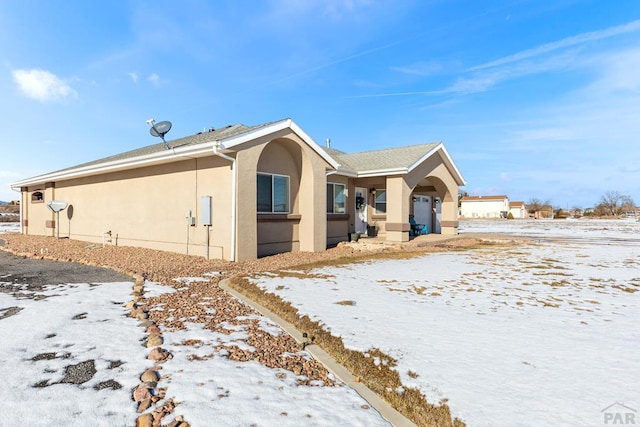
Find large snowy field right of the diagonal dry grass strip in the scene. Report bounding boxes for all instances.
[248,220,640,426]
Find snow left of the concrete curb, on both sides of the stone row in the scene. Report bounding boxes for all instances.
[0,264,389,427]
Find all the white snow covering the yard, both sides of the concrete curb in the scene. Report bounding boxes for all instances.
[0,221,640,426]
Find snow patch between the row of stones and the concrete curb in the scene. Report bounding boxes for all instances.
[162,322,389,426]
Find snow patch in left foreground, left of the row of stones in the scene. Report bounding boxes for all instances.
[0,275,151,426]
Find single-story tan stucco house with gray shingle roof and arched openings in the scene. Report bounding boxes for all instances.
[11,119,465,261]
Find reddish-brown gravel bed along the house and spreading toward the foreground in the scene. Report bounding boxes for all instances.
[0,233,512,425]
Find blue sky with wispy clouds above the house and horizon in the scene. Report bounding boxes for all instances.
[0,0,640,208]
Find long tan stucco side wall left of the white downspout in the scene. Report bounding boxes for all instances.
[28,157,236,258]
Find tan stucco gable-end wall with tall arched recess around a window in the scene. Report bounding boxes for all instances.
[238,134,326,259]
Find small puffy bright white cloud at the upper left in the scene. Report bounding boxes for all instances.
[12,68,78,102]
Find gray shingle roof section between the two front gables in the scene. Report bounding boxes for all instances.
[322,142,440,172]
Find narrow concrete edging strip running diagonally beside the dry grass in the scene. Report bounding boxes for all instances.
[219,279,415,427]
